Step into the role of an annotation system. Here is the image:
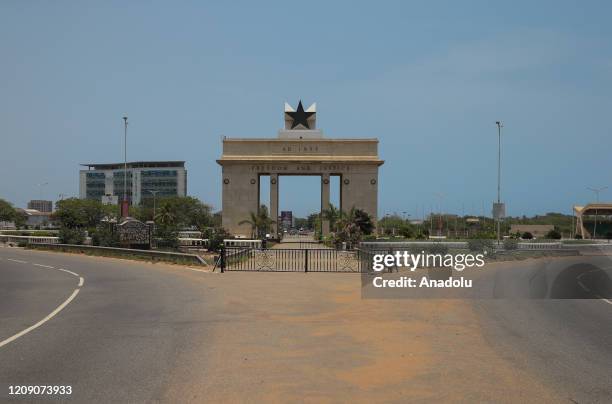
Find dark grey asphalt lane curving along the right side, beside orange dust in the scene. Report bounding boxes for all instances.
[473,257,612,403]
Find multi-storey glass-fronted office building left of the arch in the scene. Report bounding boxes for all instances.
[79,161,187,205]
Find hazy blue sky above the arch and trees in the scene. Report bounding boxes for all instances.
[0,0,612,216]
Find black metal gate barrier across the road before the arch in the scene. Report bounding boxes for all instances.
[220,247,369,273]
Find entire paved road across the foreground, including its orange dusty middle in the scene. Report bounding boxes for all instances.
[0,248,612,402]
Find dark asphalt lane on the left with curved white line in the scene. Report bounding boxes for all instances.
[0,248,220,402]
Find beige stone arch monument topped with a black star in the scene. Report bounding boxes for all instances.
[217,101,384,237]
